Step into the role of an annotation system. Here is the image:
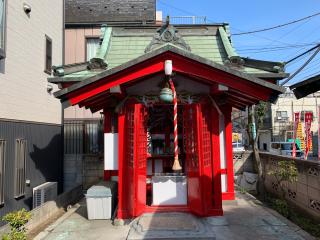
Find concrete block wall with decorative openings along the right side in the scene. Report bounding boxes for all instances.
[260,153,320,221]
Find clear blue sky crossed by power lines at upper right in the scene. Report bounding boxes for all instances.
[157,0,320,85]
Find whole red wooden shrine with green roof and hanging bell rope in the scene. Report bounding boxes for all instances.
[49,21,286,219]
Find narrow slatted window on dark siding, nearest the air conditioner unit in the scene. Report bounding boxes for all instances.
[14,139,27,198]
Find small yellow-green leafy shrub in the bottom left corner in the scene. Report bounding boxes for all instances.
[2,208,31,240]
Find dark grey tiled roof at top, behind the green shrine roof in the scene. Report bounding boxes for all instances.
[65,0,156,24]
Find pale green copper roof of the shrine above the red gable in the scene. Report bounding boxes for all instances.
[51,25,283,82]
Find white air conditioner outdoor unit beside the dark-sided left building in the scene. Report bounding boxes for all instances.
[33,182,58,208]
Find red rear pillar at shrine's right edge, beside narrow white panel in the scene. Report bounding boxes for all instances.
[222,106,235,200]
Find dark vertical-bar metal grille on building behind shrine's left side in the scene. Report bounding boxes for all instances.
[64,120,103,154]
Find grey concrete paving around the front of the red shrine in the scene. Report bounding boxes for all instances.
[38,194,313,240]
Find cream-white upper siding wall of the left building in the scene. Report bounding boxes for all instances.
[0,0,63,124]
